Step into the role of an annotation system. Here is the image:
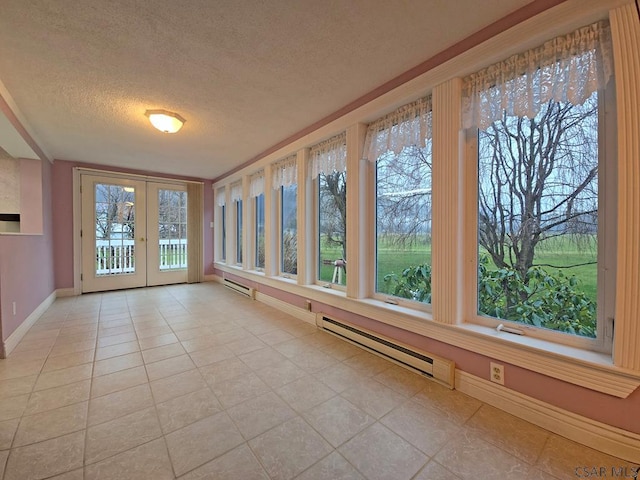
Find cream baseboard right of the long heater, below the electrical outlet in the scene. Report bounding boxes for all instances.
[456,370,640,463]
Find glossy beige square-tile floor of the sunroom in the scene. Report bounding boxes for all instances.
[0,284,627,480]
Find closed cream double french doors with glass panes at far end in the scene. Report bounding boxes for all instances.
[81,174,187,292]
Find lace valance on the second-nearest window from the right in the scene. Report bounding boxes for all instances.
[364,96,432,162]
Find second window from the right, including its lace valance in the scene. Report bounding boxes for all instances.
[365,97,431,304]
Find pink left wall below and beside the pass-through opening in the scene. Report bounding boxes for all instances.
[0,160,55,340]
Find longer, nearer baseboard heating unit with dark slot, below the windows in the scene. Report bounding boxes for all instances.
[316,313,455,388]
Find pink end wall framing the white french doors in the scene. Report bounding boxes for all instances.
[52,160,213,289]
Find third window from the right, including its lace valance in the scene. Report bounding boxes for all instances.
[309,133,347,286]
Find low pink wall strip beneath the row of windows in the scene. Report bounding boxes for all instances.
[216,269,640,434]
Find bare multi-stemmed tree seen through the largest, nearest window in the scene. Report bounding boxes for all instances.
[478,95,598,279]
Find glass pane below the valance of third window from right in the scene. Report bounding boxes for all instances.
[318,172,347,285]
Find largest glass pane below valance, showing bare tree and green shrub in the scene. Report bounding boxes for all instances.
[478,93,599,337]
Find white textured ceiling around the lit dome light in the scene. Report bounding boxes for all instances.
[0,0,530,178]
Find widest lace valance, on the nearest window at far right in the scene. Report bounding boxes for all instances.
[462,21,613,129]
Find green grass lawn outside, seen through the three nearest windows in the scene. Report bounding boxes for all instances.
[320,238,597,301]
